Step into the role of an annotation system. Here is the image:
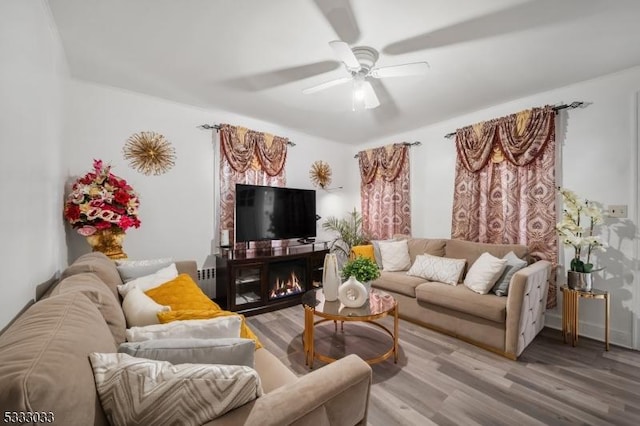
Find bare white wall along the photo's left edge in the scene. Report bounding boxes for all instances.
[0,0,68,329]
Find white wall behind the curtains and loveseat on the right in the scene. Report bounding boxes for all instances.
[360,68,640,348]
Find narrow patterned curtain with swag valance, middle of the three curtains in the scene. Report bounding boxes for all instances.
[358,144,411,239]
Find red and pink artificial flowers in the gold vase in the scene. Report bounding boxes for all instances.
[64,160,140,237]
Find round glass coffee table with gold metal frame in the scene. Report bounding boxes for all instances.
[302,289,398,368]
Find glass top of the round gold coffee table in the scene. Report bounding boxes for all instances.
[302,288,396,317]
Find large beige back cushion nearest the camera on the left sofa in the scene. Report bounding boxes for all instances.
[0,292,117,425]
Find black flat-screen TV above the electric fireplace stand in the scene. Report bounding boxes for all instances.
[235,184,316,242]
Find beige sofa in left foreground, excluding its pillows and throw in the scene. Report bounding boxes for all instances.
[0,253,371,426]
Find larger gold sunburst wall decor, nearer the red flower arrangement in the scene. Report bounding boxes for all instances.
[122,132,176,176]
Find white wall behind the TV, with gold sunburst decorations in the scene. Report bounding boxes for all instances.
[64,80,350,266]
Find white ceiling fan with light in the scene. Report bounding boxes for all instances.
[302,40,429,111]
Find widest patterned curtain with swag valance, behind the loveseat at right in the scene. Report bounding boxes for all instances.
[451,106,558,308]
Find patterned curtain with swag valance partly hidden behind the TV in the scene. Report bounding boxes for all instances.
[218,124,288,245]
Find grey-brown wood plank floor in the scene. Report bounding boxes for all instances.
[247,306,640,426]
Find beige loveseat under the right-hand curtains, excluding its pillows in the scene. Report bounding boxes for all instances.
[372,235,551,359]
